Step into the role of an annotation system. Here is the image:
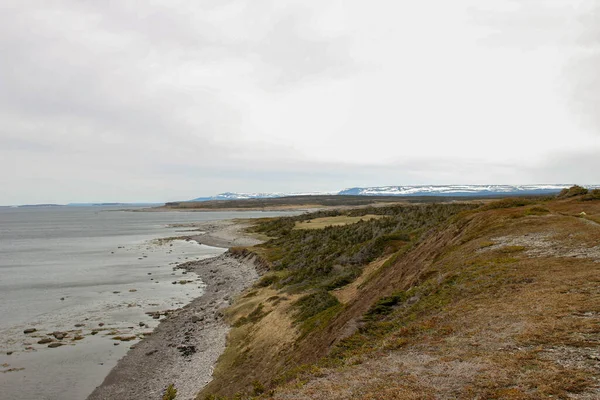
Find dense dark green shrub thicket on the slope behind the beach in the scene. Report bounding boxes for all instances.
[254,204,476,290]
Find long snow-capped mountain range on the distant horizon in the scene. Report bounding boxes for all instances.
[190,184,600,201]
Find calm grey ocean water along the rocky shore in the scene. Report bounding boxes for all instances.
[0,207,290,400]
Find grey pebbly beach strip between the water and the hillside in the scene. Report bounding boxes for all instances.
[88,220,260,400]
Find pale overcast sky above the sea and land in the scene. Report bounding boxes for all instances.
[0,0,600,205]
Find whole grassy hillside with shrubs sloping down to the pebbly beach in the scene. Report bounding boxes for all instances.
[198,190,600,399]
